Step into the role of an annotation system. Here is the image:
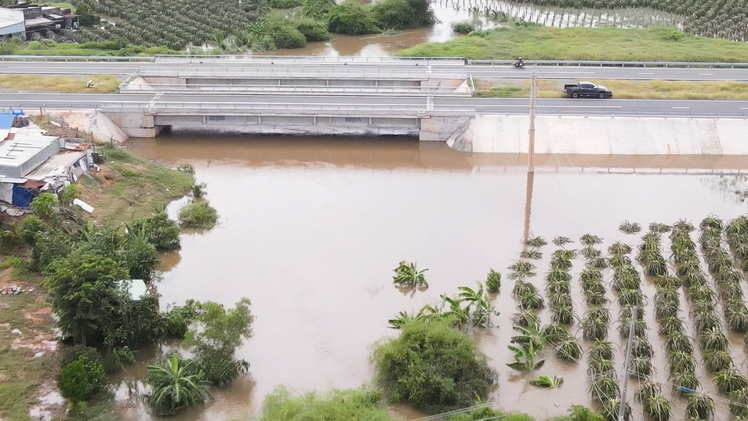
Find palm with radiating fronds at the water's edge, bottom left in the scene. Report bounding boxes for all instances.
[148,354,211,414]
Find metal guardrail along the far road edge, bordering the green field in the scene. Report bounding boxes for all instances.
[467,60,748,69]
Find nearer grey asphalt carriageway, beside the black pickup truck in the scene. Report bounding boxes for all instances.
[0,93,748,118]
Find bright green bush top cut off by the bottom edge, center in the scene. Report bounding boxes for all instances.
[260,387,395,421]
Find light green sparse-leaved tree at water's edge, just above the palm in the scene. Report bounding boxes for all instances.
[185,298,254,387]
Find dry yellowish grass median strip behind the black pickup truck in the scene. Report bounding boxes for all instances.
[474,79,748,100]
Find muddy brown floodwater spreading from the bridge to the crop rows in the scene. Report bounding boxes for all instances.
[118,132,745,421]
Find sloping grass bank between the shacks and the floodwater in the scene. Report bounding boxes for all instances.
[78,146,193,224]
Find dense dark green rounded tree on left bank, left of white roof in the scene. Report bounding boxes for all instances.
[44,252,127,346]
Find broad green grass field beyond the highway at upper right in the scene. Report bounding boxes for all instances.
[398,26,748,62]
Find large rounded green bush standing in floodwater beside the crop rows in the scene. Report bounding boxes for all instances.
[373,320,497,413]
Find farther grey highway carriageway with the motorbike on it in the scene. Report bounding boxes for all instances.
[0,60,748,82]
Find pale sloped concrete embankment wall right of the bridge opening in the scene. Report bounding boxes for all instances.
[447,116,748,155]
